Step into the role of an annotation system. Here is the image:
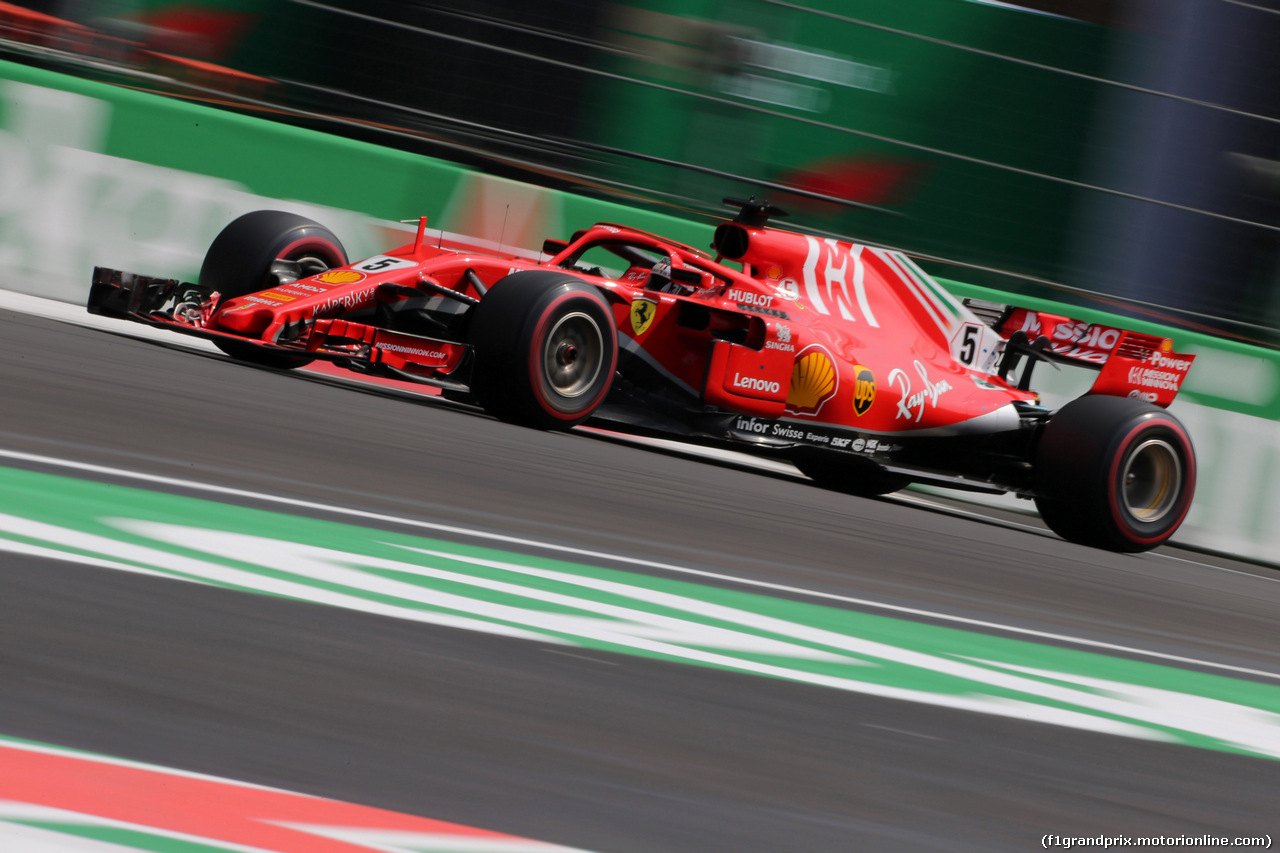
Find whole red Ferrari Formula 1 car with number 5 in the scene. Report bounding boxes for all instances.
[88,200,1196,551]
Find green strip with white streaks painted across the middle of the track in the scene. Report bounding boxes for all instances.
[0,467,1280,758]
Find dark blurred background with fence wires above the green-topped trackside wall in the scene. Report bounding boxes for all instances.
[0,0,1280,347]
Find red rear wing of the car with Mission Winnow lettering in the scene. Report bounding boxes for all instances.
[964,298,1196,406]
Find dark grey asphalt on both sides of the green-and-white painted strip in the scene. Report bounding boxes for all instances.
[0,310,1280,853]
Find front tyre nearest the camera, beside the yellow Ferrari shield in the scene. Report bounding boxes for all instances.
[468,270,618,429]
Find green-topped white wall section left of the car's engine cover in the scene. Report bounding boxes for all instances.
[0,61,708,301]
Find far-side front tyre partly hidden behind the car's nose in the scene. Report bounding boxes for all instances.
[198,210,347,368]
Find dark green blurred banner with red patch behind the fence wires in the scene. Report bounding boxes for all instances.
[593,0,1114,285]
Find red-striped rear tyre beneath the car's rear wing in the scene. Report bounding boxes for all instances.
[1033,396,1196,552]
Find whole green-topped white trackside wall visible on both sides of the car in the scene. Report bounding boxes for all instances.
[0,61,1280,564]
